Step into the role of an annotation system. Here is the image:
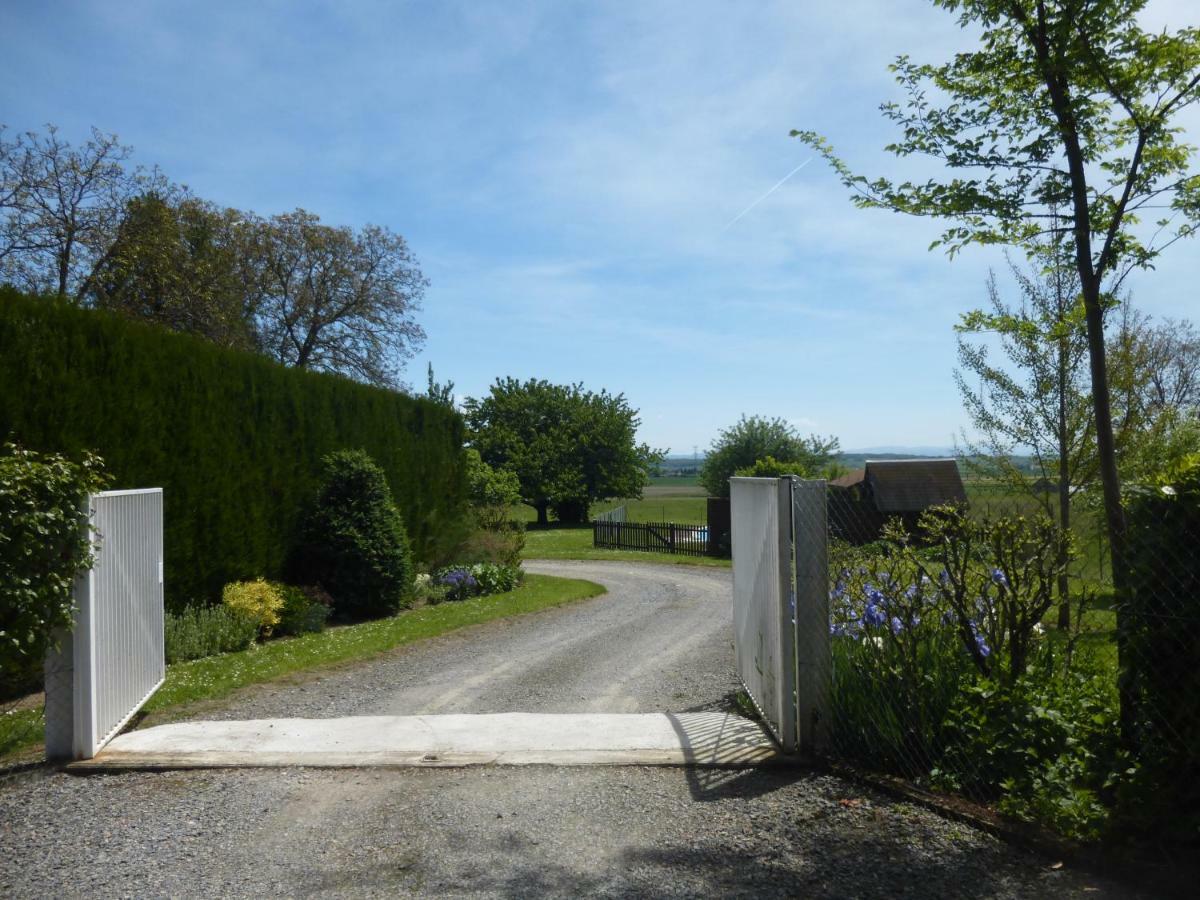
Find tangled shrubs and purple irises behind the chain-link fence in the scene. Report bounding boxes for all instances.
[829,509,1116,836]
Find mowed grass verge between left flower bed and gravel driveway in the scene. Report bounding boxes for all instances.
[0,580,605,762]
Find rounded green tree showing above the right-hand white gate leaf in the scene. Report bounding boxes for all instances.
[700,415,838,497]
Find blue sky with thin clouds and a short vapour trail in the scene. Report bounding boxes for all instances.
[0,0,1200,454]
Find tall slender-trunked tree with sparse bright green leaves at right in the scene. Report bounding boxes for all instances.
[793,0,1200,633]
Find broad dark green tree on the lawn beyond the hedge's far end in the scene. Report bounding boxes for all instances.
[463,378,662,524]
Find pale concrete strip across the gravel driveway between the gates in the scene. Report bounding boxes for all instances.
[72,712,787,769]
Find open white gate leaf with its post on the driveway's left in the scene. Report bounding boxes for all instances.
[46,488,167,760]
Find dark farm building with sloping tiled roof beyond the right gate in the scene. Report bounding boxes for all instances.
[829,460,967,544]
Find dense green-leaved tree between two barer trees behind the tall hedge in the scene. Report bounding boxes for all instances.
[86,193,257,349]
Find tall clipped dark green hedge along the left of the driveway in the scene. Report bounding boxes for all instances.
[0,287,466,610]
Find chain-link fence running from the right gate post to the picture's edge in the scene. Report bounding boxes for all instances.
[811,475,1200,845]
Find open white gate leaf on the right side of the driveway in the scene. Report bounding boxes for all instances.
[730,478,797,751]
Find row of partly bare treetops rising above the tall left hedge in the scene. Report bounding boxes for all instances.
[0,126,428,388]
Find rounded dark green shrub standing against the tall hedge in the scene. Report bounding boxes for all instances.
[298,450,413,619]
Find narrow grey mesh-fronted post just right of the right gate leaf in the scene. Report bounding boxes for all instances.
[792,476,833,755]
